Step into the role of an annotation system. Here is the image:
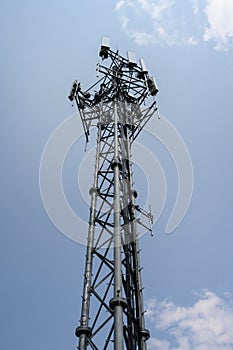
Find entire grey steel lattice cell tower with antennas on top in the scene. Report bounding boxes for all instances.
[69,37,158,350]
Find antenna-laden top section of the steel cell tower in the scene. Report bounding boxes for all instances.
[68,37,159,141]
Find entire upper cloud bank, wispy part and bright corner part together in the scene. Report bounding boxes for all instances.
[115,0,233,51]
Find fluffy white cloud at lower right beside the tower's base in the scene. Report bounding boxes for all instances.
[146,291,233,350]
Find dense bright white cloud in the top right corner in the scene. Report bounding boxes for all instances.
[203,0,233,51]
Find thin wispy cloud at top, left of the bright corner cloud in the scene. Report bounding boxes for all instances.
[116,0,198,46]
